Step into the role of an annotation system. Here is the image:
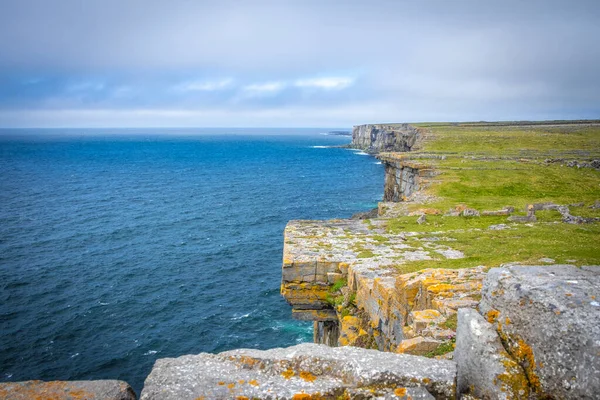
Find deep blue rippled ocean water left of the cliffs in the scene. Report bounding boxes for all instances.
[0,129,383,393]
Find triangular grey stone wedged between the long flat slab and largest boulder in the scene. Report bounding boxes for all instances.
[454,308,529,400]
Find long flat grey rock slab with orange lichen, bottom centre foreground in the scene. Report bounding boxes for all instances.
[141,343,456,400]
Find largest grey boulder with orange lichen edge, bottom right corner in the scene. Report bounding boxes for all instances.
[480,265,600,399]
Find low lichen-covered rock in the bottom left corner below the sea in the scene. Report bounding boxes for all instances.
[0,380,136,400]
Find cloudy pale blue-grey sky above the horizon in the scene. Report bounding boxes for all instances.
[0,0,600,127]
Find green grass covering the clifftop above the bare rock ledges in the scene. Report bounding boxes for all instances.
[382,121,600,272]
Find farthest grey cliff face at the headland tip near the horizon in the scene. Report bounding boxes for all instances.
[352,124,421,154]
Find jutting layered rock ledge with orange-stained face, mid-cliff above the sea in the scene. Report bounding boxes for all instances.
[281,220,484,354]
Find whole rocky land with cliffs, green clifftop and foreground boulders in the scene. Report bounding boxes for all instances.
[0,121,600,400]
